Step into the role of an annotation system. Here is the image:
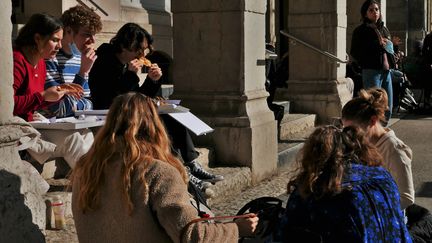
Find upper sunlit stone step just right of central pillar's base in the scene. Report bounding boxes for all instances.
[279,114,316,141]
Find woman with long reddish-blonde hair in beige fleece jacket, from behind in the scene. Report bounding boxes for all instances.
[72,93,258,242]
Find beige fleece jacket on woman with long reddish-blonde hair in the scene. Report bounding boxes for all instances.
[72,159,238,243]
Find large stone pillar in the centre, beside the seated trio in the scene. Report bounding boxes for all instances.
[172,0,277,181]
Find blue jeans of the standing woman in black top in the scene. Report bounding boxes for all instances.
[362,69,393,121]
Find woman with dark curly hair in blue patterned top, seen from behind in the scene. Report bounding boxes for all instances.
[280,126,411,242]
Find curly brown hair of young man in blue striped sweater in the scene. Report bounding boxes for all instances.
[61,5,102,34]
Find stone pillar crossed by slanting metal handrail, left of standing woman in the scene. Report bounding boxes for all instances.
[277,0,352,123]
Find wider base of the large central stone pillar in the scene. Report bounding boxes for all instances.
[175,91,277,181]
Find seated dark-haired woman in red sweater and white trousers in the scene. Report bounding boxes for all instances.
[13,14,93,168]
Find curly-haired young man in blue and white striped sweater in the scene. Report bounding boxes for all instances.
[45,5,102,118]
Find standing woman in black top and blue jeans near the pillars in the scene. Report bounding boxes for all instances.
[350,0,395,122]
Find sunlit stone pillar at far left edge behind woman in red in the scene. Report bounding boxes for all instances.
[0,1,46,242]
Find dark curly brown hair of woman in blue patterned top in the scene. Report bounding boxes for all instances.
[288,126,382,199]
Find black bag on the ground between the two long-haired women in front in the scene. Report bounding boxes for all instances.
[237,197,285,242]
